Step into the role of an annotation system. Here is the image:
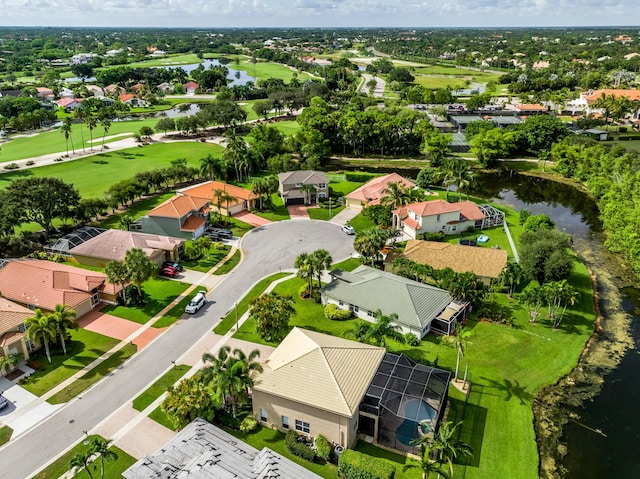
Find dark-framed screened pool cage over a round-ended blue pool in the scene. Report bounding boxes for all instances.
[360,353,451,454]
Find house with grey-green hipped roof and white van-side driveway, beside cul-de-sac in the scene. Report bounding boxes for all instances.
[320,265,466,339]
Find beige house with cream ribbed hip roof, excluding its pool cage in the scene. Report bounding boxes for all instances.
[252,328,385,447]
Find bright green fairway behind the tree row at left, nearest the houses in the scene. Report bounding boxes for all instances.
[0,141,222,198]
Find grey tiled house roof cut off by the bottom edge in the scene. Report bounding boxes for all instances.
[122,418,320,479]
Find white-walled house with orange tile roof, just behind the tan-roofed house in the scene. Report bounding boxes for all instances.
[392,200,486,239]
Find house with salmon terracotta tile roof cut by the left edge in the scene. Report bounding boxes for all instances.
[0,259,122,317]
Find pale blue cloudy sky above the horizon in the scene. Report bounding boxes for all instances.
[0,0,640,28]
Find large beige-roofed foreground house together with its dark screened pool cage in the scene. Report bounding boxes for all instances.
[252,328,451,453]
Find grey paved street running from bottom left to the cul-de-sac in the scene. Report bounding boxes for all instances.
[0,221,353,479]
